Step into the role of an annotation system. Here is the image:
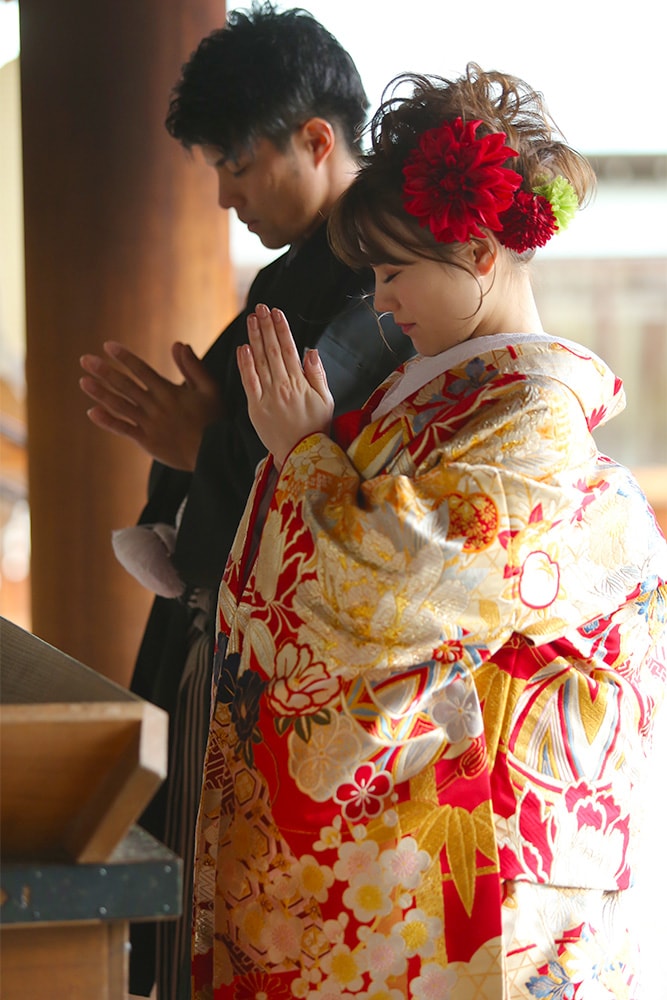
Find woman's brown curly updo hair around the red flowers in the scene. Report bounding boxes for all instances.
[329,63,595,269]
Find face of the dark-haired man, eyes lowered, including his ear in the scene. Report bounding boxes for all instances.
[201,130,326,250]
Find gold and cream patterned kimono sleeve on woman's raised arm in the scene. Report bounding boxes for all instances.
[243,383,664,675]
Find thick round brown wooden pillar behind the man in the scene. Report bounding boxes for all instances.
[20,0,236,683]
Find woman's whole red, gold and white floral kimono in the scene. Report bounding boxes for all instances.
[193,335,667,1000]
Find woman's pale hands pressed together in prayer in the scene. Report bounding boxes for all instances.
[237,305,334,469]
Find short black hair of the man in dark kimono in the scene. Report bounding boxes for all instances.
[166,3,369,156]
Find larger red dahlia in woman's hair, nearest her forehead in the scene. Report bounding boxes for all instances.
[403,117,522,243]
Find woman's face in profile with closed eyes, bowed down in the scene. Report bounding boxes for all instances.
[373,244,497,356]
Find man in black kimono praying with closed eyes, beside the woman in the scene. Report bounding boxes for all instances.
[81,3,413,1000]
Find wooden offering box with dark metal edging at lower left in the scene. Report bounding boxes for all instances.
[0,618,181,1000]
